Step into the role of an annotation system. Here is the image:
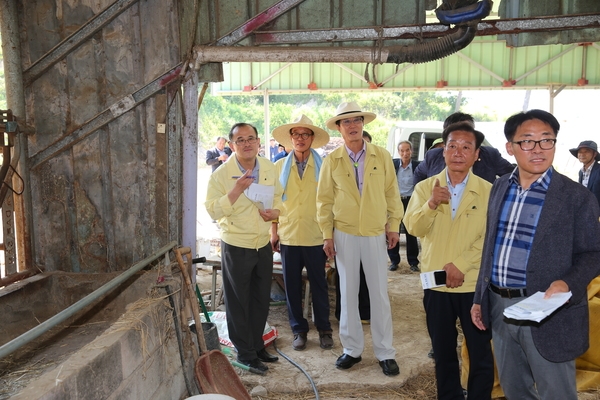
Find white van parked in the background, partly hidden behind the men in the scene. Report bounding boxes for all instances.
[385,121,491,161]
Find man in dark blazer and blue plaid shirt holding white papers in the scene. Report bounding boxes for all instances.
[469,110,600,400]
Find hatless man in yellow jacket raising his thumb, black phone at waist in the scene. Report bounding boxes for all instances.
[404,122,494,399]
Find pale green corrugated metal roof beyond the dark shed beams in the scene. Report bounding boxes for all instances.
[213,37,600,94]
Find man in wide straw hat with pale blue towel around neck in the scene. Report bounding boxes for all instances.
[271,115,333,350]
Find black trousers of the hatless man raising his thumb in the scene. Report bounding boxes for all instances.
[423,290,494,400]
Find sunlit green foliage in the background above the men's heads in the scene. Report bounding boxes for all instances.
[199,91,466,148]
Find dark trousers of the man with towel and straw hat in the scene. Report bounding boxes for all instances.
[280,244,331,333]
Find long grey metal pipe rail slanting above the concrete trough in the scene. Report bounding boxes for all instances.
[0,242,177,360]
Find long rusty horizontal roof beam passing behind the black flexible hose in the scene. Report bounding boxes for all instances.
[254,13,600,45]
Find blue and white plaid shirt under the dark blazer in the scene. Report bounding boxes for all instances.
[491,167,552,288]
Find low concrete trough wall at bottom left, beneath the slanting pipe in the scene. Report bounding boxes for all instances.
[12,282,195,400]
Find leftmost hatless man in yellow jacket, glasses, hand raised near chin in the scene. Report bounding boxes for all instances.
[205,123,282,371]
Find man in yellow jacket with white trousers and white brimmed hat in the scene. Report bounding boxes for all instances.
[317,102,404,375]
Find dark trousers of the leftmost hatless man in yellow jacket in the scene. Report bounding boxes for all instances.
[221,241,273,361]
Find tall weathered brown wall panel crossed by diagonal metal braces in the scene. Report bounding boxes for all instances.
[20,0,180,272]
